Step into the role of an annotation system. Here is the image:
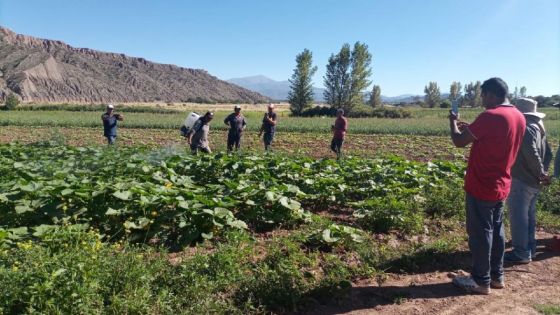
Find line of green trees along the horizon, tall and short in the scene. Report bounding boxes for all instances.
[288,47,560,115]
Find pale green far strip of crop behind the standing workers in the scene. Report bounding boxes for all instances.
[0,109,560,137]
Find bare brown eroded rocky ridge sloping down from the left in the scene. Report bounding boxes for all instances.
[0,27,268,103]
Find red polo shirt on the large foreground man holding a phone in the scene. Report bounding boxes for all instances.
[465,104,525,201]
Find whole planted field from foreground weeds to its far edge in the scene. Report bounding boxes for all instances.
[0,110,560,314]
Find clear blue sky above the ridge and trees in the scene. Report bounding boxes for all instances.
[0,0,560,96]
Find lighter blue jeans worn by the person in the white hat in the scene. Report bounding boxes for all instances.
[507,178,540,259]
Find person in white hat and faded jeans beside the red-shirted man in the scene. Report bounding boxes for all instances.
[504,98,552,264]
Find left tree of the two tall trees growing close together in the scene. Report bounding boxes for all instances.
[323,44,352,108]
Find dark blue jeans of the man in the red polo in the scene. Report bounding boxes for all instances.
[466,193,505,287]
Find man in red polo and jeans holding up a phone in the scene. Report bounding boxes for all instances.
[449,78,525,294]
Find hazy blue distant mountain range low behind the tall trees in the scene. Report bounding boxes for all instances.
[227,75,423,103]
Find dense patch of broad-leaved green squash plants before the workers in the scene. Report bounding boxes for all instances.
[0,144,463,246]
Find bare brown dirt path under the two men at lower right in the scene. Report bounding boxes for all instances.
[309,232,560,315]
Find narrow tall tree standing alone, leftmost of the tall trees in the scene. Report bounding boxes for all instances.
[288,49,317,115]
